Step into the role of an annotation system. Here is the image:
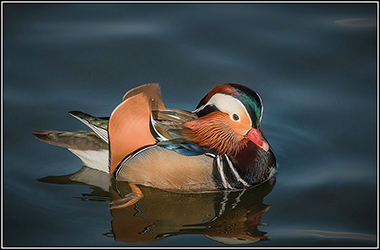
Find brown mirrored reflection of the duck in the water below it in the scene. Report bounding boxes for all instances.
[39,166,276,245]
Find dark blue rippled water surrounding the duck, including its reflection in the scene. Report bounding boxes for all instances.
[2,3,378,247]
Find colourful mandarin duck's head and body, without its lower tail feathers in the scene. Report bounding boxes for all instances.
[70,83,277,192]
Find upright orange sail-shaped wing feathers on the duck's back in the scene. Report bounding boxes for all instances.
[108,84,166,174]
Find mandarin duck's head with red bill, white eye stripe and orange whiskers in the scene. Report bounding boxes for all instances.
[184,83,269,155]
